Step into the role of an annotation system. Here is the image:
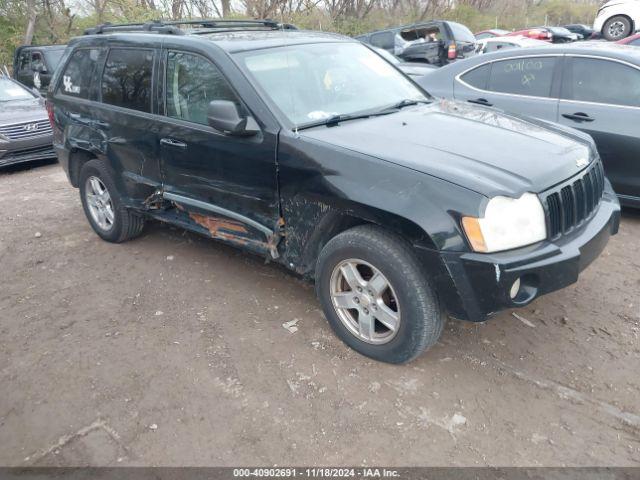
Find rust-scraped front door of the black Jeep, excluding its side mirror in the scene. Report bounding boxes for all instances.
[158,50,280,257]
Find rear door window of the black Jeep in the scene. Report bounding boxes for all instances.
[101,48,153,112]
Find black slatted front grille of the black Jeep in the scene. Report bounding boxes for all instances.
[543,160,604,240]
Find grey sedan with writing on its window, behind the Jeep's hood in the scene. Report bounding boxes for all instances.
[416,42,640,208]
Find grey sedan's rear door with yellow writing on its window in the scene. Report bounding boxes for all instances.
[455,55,562,122]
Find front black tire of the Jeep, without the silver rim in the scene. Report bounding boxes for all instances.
[316,225,445,363]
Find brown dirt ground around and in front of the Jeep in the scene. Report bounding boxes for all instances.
[0,159,640,466]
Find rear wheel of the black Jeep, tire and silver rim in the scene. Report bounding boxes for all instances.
[79,160,144,243]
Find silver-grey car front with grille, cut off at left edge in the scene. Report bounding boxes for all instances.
[0,77,56,167]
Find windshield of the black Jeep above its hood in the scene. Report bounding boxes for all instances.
[238,43,429,127]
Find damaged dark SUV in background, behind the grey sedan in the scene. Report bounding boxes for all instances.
[355,20,476,66]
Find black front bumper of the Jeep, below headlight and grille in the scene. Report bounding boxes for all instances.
[420,182,620,322]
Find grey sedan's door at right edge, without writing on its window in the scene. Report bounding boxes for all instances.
[559,56,640,202]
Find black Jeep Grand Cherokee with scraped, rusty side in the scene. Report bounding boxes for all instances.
[48,21,620,363]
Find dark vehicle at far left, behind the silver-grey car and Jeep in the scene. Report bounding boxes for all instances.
[13,45,66,93]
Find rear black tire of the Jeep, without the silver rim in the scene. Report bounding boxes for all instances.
[79,159,144,243]
